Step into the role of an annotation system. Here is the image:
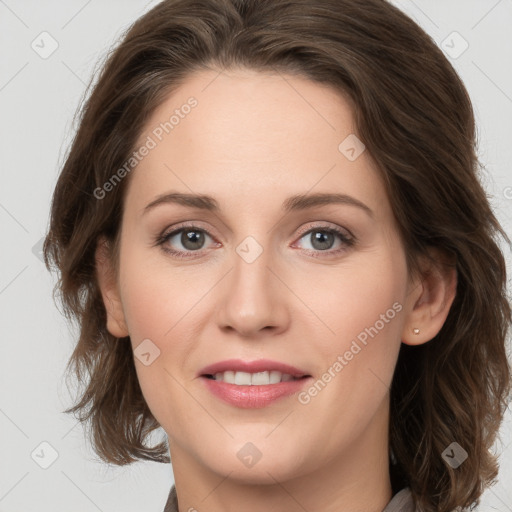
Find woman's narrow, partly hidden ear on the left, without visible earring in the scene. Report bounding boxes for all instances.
[95,237,128,338]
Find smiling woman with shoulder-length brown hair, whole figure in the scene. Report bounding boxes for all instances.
[45,0,511,512]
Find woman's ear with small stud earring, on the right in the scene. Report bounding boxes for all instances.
[402,248,457,345]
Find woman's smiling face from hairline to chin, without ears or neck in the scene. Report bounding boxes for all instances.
[98,70,426,483]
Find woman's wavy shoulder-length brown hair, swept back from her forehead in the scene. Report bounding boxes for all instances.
[44,0,511,511]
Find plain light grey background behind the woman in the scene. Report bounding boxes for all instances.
[0,0,512,512]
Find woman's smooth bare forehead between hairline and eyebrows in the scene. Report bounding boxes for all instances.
[127,70,386,218]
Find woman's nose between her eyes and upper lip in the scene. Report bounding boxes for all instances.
[218,242,292,338]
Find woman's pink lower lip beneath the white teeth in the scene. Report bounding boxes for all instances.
[201,376,311,409]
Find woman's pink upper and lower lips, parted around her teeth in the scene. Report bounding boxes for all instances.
[198,359,312,409]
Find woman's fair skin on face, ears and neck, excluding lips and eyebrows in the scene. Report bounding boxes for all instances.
[97,69,456,512]
